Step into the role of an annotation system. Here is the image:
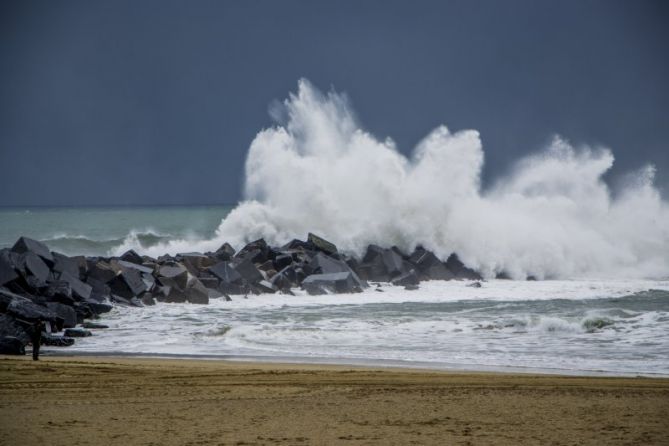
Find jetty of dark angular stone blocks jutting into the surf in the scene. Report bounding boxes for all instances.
[0,234,481,354]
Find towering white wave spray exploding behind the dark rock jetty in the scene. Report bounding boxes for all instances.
[128,80,669,279]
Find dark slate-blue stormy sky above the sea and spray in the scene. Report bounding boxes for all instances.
[0,0,669,206]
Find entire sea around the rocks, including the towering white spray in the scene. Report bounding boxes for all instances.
[0,80,669,376]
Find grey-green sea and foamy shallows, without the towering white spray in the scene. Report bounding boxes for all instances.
[0,206,669,376]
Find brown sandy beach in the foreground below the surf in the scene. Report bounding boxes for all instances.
[0,356,669,446]
